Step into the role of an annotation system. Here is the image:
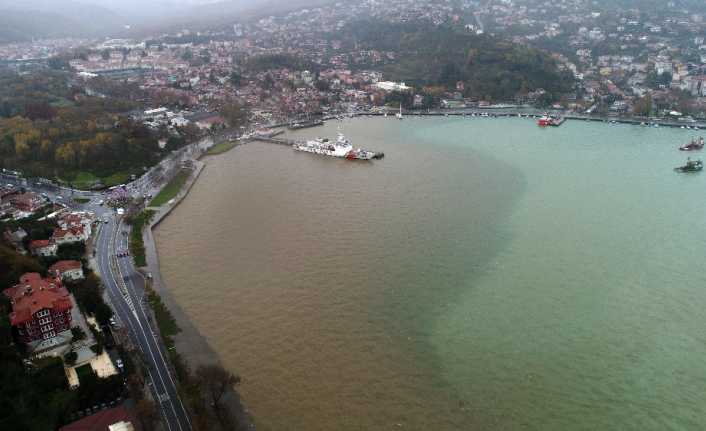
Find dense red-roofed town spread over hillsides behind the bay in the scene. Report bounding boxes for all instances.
[0,0,706,122]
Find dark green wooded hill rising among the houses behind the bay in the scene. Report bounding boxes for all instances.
[344,21,574,101]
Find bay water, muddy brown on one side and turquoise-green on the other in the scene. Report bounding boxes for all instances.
[155,117,706,431]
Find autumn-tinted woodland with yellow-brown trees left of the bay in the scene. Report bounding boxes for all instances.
[0,71,173,188]
